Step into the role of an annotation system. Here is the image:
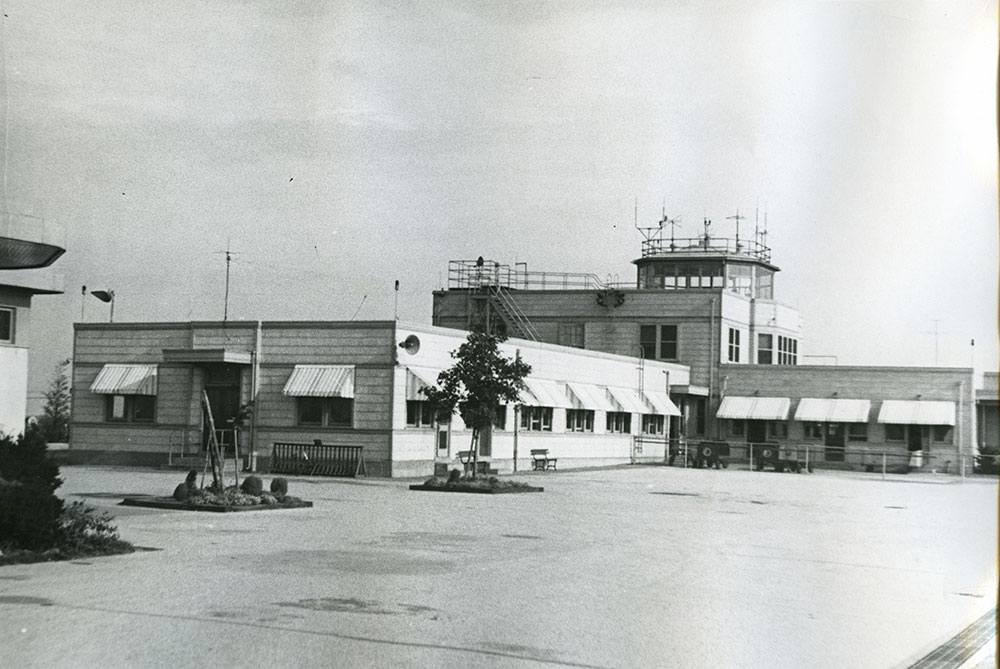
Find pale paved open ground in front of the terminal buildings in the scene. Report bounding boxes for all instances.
[0,466,997,668]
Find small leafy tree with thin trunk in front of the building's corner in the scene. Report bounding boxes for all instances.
[421,331,531,478]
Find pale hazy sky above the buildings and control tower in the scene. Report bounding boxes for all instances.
[0,0,1000,402]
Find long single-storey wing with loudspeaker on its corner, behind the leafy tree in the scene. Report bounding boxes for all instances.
[63,321,690,476]
